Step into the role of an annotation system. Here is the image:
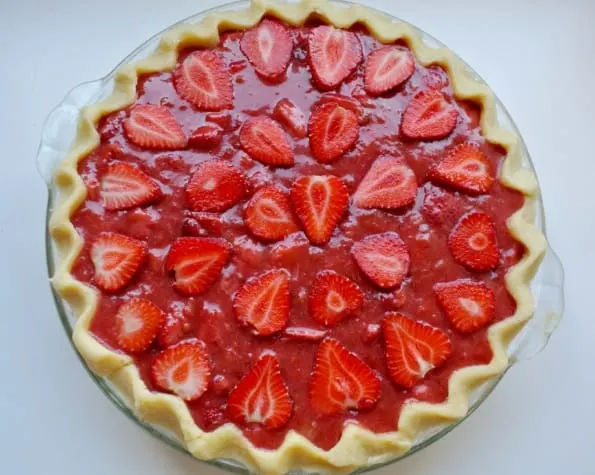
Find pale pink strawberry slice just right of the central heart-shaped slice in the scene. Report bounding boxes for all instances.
[353,157,417,209]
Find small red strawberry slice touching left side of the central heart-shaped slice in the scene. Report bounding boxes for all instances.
[244,185,299,241]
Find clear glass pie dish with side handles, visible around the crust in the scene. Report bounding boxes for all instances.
[38,2,563,473]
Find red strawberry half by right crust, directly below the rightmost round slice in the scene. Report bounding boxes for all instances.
[434,279,496,333]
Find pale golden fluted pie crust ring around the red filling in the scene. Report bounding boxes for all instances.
[49,0,547,474]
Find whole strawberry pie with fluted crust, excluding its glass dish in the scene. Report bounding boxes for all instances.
[50,2,545,474]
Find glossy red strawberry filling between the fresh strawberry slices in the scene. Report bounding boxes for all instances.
[72,22,523,449]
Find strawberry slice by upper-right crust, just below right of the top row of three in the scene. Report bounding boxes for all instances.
[401,90,459,140]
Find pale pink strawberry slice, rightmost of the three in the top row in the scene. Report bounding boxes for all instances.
[364,46,415,96]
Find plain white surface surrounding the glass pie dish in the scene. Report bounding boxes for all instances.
[0,0,595,475]
